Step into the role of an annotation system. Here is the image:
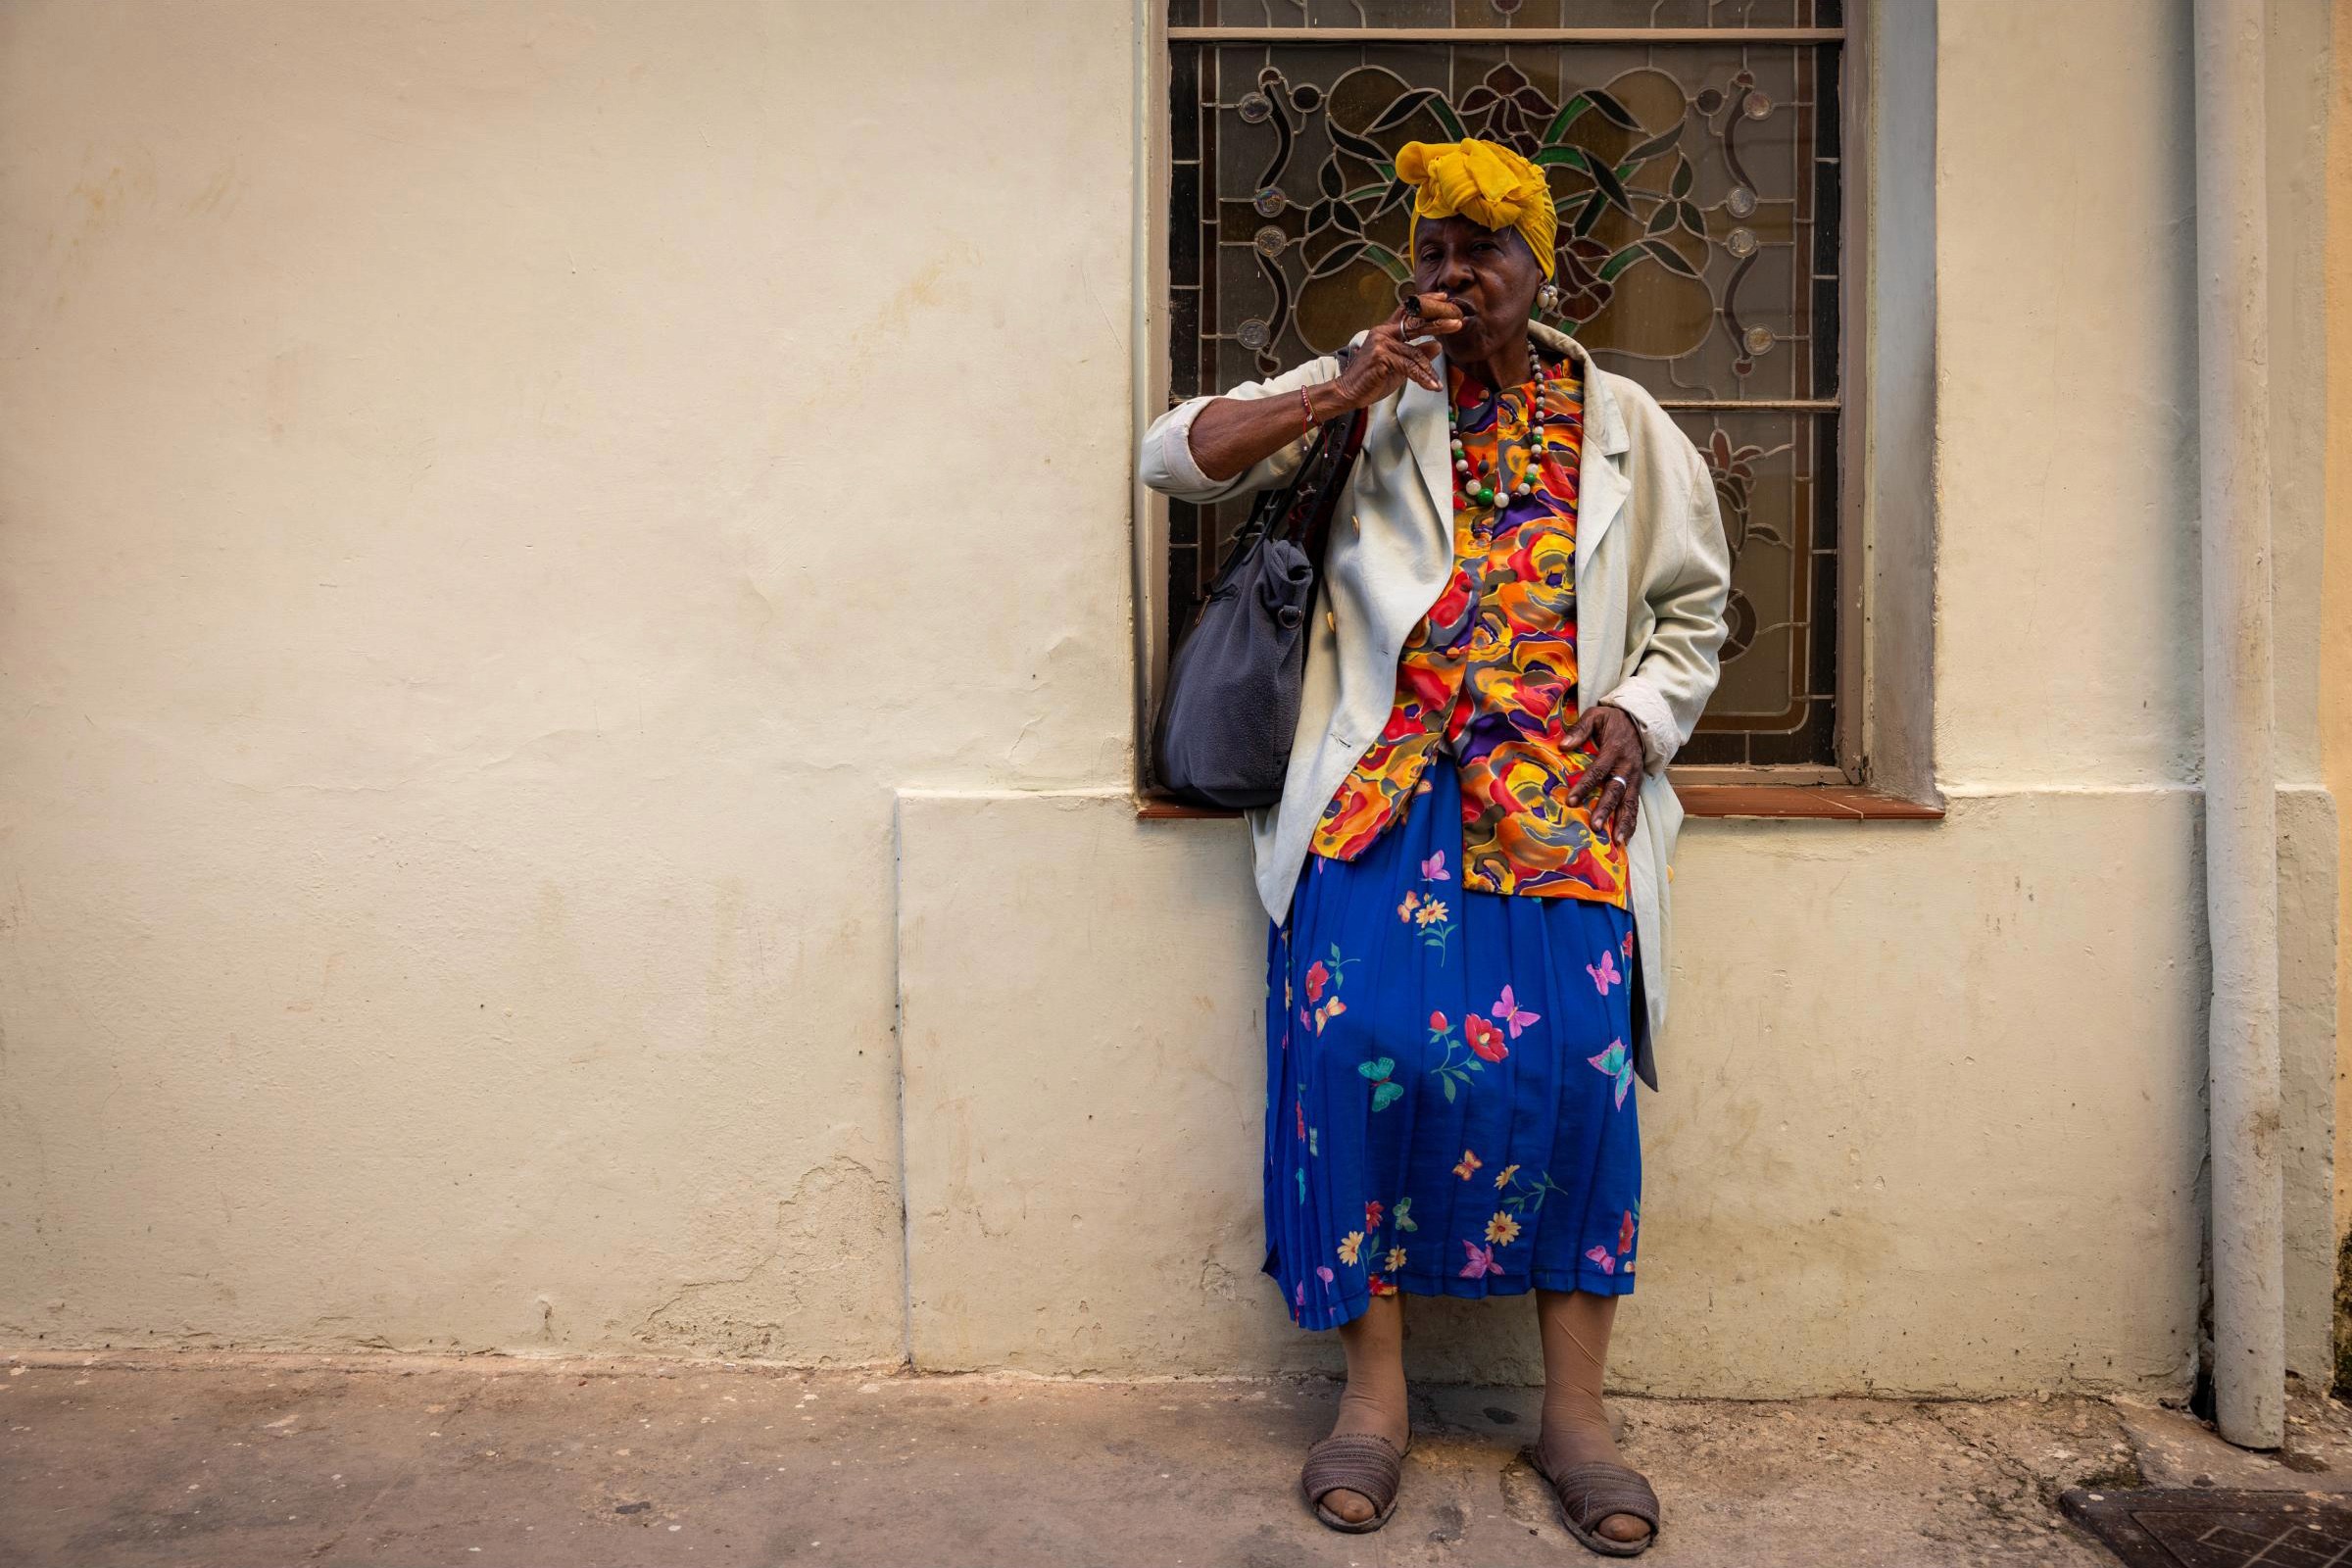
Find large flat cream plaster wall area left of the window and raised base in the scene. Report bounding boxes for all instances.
[0,0,1134,1361]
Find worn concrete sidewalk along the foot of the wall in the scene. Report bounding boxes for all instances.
[14,1354,2352,1568]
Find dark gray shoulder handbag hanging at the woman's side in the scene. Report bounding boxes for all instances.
[1152,392,1366,808]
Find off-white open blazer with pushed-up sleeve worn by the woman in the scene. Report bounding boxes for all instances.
[1141,322,1731,1089]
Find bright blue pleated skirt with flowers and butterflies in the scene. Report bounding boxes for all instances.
[1265,766,1642,1328]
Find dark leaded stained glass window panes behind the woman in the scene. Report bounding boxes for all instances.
[1166,0,1844,766]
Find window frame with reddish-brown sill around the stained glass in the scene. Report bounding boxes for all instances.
[1131,0,1942,820]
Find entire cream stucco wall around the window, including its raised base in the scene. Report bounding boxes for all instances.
[0,0,2335,1394]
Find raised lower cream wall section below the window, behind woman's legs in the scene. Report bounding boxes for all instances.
[901,790,2204,1396]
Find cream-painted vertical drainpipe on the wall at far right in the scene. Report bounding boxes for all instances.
[2194,0,2286,1448]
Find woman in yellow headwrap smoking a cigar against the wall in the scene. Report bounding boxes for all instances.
[1143,141,1729,1556]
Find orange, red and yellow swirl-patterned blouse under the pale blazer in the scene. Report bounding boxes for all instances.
[1312,350,1625,906]
